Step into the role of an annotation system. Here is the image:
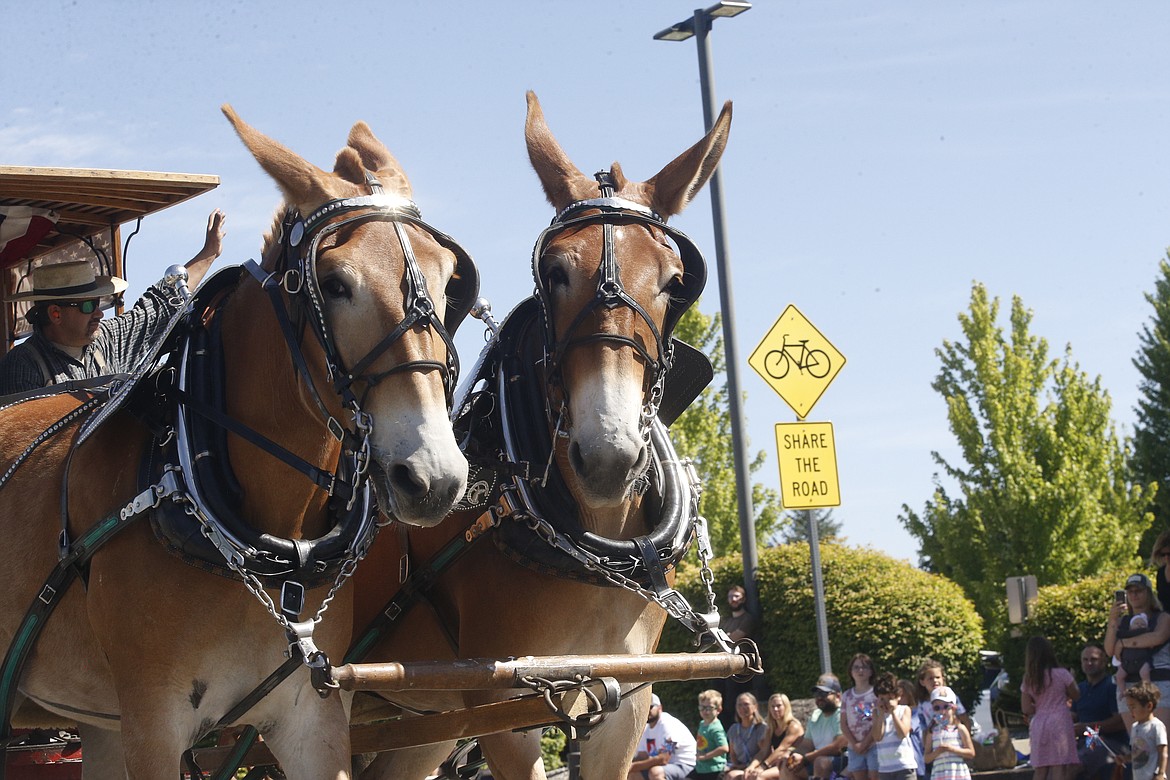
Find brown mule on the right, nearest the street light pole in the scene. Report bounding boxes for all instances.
[355,92,731,780]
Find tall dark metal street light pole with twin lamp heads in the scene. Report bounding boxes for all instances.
[654,0,759,615]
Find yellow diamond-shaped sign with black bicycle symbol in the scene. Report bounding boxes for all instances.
[748,304,845,420]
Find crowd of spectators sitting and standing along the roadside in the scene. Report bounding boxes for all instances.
[628,549,1170,780]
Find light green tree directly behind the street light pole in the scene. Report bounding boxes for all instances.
[670,305,780,555]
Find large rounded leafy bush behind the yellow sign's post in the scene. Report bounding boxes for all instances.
[655,544,984,725]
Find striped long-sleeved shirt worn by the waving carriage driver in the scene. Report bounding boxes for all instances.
[0,282,179,395]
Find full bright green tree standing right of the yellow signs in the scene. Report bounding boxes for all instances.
[899,283,1152,624]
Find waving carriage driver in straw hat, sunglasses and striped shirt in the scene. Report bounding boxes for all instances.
[0,208,226,395]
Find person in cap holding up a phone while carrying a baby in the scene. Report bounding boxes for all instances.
[1104,573,1170,729]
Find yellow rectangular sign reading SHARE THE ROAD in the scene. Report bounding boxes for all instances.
[776,422,841,509]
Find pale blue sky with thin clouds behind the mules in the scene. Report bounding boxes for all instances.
[9,0,1170,568]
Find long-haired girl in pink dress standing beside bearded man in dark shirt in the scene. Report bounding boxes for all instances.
[1020,636,1081,780]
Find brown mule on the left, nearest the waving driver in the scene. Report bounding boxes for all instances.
[0,106,474,780]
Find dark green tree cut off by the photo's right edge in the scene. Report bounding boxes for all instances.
[1130,253,1170,553]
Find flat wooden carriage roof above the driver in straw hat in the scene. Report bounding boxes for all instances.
[0,165,219,258]
